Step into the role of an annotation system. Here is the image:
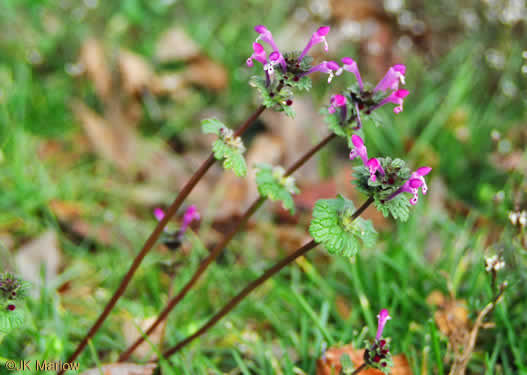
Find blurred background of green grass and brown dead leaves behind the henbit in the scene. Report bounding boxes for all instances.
[0,0,527,374]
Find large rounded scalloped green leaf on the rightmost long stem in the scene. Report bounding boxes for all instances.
[309,195,377,256]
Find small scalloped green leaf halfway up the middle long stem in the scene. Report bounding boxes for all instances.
[256,164,299,214]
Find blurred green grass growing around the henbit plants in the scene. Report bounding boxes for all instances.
[0,0,527,375]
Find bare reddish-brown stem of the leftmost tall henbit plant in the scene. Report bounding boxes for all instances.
[58,105,265,375]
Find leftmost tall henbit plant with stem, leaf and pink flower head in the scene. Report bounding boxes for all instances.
[59,21,339,374]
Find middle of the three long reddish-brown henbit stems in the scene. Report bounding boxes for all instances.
[118,133,336,362]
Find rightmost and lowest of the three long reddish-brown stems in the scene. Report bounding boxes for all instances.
[157,197,373,362]
